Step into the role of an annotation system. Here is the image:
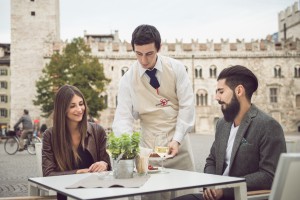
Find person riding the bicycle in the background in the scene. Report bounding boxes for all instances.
[14,109,33,151]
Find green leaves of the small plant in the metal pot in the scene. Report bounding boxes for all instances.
[107,132,140,159]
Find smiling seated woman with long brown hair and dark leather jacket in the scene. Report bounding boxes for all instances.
[42,85,111,197]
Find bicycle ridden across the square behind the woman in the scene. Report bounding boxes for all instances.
[4,131,42,155]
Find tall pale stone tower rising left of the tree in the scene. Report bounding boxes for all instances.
[10,0,60,126]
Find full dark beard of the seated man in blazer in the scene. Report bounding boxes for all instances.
[219,94,240,122]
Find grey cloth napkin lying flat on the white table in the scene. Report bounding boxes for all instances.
[66,174,150,189]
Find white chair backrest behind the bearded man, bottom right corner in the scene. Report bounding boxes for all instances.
[269,153,300,200]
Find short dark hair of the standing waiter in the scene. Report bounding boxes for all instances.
[131,24,161,51]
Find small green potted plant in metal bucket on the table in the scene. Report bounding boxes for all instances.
[107,132,140,178]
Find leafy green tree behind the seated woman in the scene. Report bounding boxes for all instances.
[33,38,110,117]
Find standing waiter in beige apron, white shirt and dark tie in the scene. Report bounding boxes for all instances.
[112,25,195,198]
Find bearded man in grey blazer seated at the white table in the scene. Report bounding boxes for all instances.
[175,65,286,200]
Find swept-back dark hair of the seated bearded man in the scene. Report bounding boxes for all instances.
[217,65,258,101]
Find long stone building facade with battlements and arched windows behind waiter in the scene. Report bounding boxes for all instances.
[85,32,300,133]
